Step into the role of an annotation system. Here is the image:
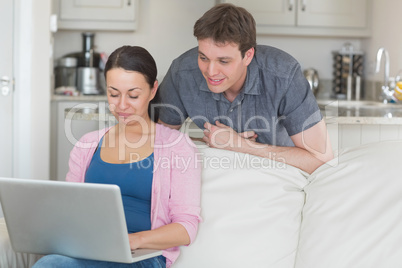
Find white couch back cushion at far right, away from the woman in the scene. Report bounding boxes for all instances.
[296,141,402,268]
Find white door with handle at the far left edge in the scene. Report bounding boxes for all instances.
[0,0,14,177]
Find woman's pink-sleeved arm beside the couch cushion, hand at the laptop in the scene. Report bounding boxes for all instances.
[129,134,202,249]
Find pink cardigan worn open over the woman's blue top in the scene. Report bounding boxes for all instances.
[66,124,202,267]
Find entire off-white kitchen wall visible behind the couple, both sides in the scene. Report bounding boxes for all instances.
[51,0,402,81]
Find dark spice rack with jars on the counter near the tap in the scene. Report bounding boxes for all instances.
[332,43,364,100]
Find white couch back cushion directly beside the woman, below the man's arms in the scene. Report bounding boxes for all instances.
[173,148,307,268]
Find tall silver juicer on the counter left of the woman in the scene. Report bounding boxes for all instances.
[56,32,106,95]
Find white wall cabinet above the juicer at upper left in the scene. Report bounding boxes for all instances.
[54,0,139,31]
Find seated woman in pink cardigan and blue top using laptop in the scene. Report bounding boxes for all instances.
[34,46,201,268]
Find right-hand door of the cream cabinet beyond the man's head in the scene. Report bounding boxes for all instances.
[297,0,367,28]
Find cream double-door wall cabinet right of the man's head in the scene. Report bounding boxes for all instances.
[220,0,371,37]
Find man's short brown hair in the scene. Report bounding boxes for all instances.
[194,3,257,57]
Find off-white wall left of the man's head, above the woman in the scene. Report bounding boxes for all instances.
[55,0,215,79]
